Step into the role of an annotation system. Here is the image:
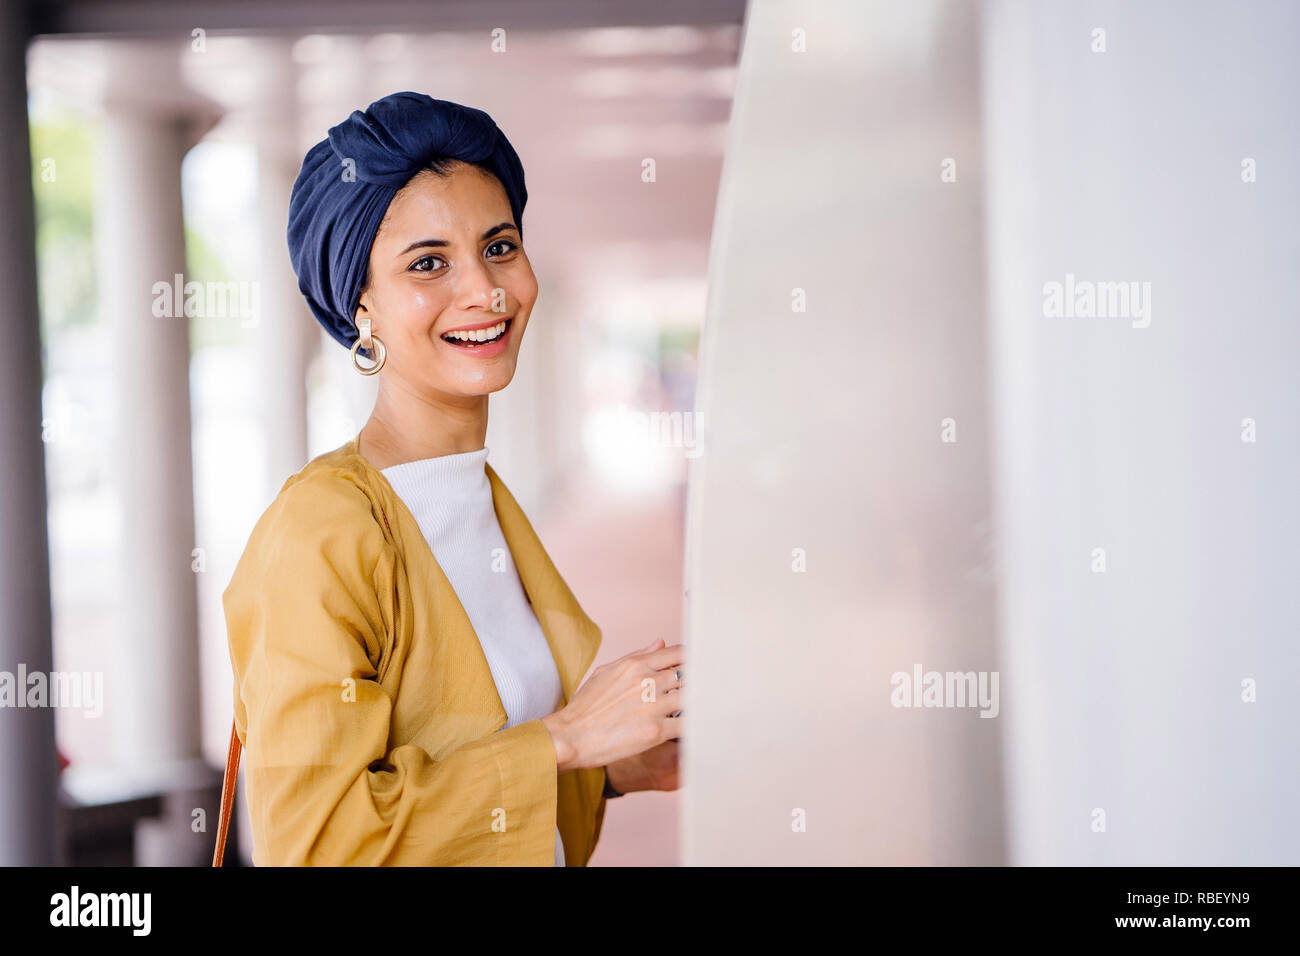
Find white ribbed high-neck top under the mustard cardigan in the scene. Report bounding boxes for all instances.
[382,447,564,866]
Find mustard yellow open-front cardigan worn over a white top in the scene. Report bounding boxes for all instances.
[222,438,606,866]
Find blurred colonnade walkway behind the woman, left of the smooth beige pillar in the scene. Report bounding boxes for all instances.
[8,3,744,864]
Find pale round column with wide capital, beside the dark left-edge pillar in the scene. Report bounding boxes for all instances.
[95,42,224,865]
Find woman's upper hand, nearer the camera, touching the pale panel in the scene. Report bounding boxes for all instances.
[542,637,686,773]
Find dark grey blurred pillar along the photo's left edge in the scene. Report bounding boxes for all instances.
[0,0,57,866]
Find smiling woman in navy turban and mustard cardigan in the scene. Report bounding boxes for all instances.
[224,92,683,866]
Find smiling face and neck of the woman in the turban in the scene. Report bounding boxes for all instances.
[358,161,537,429]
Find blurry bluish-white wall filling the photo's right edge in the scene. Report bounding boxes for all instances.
[983,3,1300,865]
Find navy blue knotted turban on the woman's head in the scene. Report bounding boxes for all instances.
[289,92,528,349]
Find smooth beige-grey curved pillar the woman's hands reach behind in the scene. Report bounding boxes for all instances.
[683,0,1002,865]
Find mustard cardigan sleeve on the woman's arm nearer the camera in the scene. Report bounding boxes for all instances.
[224,480,556,865]
